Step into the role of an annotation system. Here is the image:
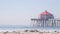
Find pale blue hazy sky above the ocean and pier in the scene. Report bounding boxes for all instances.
[0,0,60,25]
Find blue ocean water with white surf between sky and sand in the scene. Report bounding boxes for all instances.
[0,25,60,31]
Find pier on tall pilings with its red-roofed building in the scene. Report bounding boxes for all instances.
[31,10,60,27]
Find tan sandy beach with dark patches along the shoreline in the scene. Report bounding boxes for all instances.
[0,30,60,34]
